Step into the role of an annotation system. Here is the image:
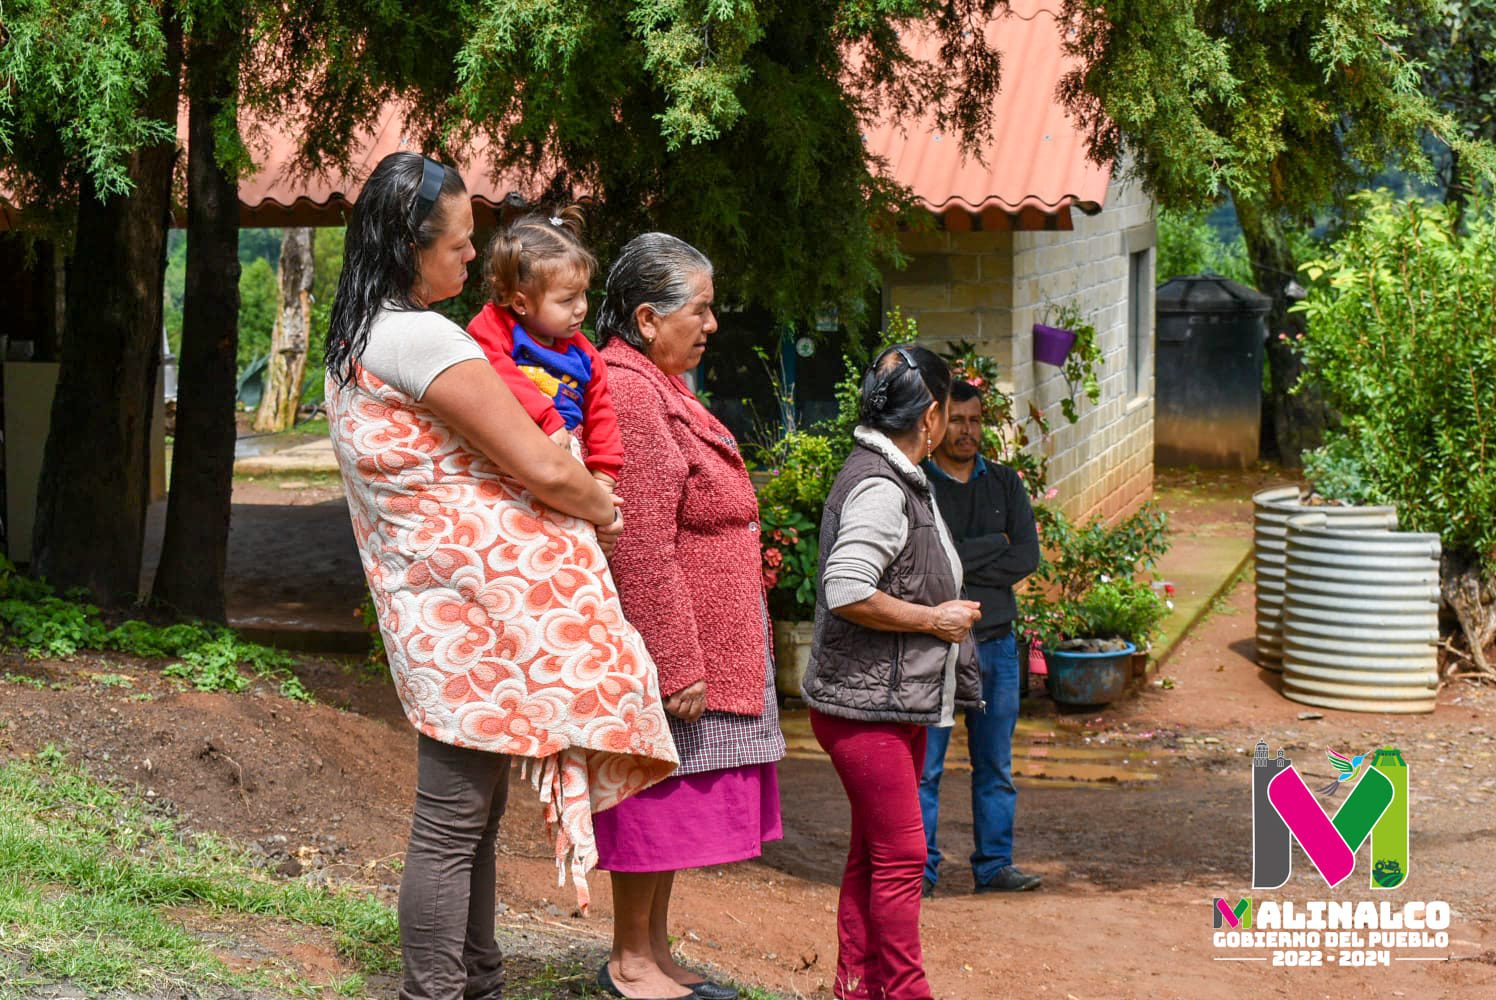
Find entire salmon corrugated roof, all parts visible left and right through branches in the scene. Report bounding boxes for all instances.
[0,0,1112,231]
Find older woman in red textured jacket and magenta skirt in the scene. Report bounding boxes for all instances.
[597,232,784,1000]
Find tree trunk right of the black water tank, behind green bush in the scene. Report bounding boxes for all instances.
[1236,199,1328,469]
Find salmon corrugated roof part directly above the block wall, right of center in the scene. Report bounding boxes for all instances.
[868,0,1112,229]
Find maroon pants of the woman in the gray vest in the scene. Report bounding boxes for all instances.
[811,710,932,1000]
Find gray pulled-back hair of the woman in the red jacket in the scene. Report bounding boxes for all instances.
[597,232,712,352]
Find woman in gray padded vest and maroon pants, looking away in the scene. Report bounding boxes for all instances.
[803,344,981,1000]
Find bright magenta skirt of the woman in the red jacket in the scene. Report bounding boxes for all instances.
[592,763,784,871]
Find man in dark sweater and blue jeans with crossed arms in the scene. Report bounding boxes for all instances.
[920,382,1040,895]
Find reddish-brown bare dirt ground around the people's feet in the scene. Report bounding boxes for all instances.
[0,565,1496,1000]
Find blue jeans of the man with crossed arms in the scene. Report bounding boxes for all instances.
[920,633,1019,885]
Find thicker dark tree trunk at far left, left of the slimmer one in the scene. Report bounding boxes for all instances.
[31,19,181,606]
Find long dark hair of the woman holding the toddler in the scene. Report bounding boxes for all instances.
[326,153,467,385]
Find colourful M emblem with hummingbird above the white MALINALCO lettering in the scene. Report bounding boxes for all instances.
[1250,741,1408,892]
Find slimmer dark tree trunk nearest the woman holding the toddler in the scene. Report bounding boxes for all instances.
[153,16,239,621]
